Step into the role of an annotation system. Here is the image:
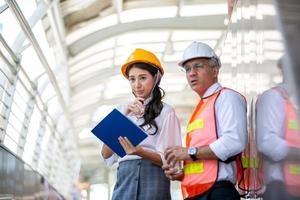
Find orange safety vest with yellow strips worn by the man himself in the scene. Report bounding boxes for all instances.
[181,88,223,199]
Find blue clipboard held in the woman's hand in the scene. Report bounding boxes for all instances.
[92,109,148,157]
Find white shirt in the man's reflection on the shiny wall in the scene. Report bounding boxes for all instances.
[256,84,288,183]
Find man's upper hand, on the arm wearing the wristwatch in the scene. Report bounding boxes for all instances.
[165,146,190,167]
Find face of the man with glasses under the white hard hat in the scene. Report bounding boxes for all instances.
[183,58,219,97]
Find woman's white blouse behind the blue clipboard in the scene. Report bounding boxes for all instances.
[105,103,182,165]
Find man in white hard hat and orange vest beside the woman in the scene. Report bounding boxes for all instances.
[163,42,247,200]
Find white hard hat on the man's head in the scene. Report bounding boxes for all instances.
[178,41,221,67]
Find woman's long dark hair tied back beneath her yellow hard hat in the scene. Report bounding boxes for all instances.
[126,62,165,135]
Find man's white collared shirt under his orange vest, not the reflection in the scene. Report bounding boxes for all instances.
[202,83,247,183]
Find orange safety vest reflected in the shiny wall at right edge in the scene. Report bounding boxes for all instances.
[274,87,300,196]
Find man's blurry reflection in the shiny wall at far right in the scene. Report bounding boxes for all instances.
[256,57,300,200]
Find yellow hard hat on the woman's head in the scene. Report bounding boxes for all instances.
[121,49,164,78]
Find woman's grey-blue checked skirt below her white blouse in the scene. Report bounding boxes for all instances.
[112,159,171,200]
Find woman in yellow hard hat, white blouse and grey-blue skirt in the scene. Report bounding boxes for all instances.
[101,49,181,200]
